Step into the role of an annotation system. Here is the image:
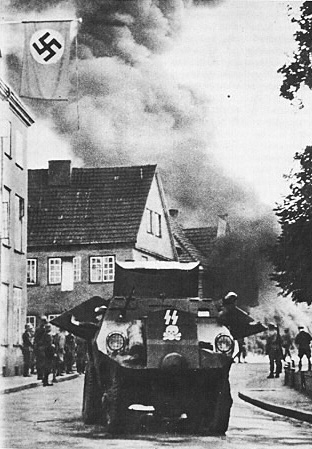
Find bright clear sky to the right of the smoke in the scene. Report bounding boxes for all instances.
[160,0,312,206]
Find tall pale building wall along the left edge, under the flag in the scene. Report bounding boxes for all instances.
[0,79,33,376]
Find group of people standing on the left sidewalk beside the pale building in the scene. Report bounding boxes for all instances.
[22,316,87,386]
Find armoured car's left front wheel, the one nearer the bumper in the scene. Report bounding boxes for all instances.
[102,367,127,433]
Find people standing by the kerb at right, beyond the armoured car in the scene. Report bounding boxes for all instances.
[266,323,312,378]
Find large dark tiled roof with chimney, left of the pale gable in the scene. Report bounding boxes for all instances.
[28,161,156,247]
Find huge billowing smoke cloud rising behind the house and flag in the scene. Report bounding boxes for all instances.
[7,0,275,308]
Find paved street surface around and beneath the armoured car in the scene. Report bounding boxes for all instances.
[1,363,312,449]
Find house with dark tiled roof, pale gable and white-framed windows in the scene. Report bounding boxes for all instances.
[27,161,177,325]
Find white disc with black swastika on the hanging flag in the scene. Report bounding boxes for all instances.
[29,29,65,64]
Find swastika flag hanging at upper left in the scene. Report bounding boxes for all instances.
[20,22,70,100]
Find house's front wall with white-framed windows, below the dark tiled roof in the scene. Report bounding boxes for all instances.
[27,247,137,321]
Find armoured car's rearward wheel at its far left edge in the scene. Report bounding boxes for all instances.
[82,360,101,424]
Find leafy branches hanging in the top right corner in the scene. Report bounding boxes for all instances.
[278,1,312,100]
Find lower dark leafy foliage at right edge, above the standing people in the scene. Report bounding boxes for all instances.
[271,146,312,304]
